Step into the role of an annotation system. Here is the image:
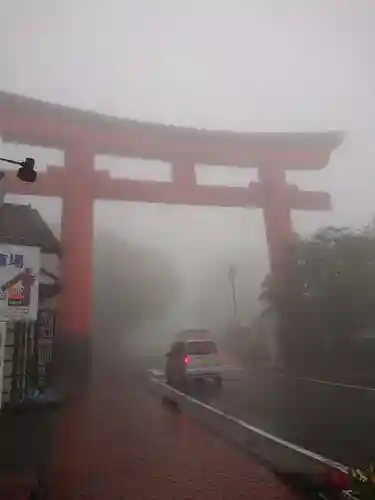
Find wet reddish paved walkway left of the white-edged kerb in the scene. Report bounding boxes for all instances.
[50,369,302,500]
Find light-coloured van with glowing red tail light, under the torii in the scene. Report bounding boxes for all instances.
[165,339,223,385]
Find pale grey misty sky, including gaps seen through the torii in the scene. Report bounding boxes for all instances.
[0,0,375,348]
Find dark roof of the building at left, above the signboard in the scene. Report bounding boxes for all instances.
[0,203,62,257]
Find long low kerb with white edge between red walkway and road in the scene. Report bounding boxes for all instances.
[151,377,355,500]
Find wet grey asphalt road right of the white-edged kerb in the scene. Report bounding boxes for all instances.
[147,360,375,466]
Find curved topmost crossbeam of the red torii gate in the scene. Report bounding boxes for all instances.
[0,92,342,170]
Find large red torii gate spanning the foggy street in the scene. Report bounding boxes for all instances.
[0,93,342,390]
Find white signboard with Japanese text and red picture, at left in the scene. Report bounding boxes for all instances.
[0,244,40,321]
